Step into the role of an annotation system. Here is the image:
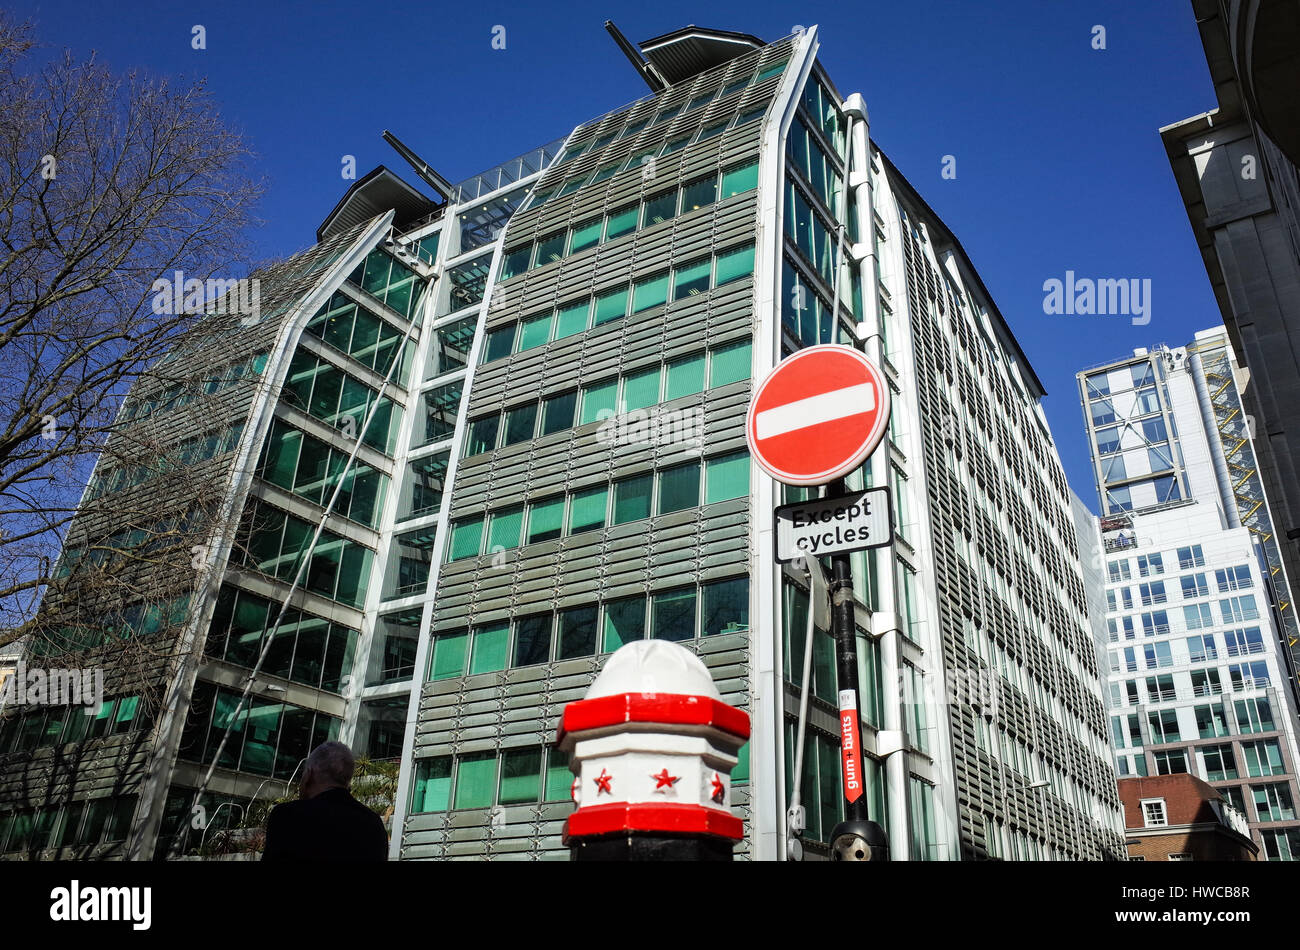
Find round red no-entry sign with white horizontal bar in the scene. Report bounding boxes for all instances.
[745,343,889,485]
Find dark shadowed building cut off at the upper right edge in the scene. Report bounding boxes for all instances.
[1160,0,1300,658]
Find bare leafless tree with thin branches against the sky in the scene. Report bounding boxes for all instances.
[0,13,260,646]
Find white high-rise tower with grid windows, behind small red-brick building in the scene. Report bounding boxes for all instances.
[1079,329,1300,860]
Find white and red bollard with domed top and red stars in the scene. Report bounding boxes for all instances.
[558,639,749,860]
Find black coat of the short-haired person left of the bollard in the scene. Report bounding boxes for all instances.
[261,789,389,862]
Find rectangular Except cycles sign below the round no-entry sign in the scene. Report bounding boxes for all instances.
[776,487,893,564]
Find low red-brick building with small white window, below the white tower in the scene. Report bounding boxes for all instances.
[1119,775,1260,860]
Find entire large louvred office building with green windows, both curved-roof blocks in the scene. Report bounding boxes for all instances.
[0,20,1123,860]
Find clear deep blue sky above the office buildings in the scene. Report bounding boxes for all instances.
[8,0,1219,508]
